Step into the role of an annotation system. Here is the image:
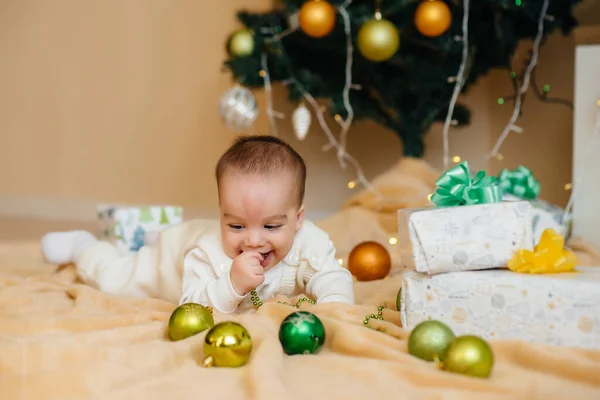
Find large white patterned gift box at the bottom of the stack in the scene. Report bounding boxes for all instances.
[400,267,600,348]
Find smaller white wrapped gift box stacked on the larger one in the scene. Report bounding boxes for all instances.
[398,201,533,274]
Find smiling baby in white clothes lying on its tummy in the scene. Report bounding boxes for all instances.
[41,136,354,313]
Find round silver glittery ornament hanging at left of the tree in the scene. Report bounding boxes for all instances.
[219,86,258,131]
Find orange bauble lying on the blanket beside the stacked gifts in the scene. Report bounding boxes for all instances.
[348,241,392,281]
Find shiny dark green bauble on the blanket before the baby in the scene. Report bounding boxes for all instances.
[279,311,325,355]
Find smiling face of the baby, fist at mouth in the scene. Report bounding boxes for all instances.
[219,170,304,270]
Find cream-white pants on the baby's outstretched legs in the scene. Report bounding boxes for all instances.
[75,219,219,303]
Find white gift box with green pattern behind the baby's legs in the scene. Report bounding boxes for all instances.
[98,205,183,254]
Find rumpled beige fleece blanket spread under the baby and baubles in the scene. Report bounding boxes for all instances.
[0,158,600,400]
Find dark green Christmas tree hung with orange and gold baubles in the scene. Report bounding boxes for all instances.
[225,0,580,157]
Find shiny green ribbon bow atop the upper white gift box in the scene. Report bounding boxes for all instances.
[430,161,502,207]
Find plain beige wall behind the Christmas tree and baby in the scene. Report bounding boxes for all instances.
[0,0,598,222]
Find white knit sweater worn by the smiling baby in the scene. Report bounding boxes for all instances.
[179,221,354,313]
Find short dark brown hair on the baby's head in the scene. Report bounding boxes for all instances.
[215,135,306,205]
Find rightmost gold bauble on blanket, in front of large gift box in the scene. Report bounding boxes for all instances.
[444,335,494,378]
